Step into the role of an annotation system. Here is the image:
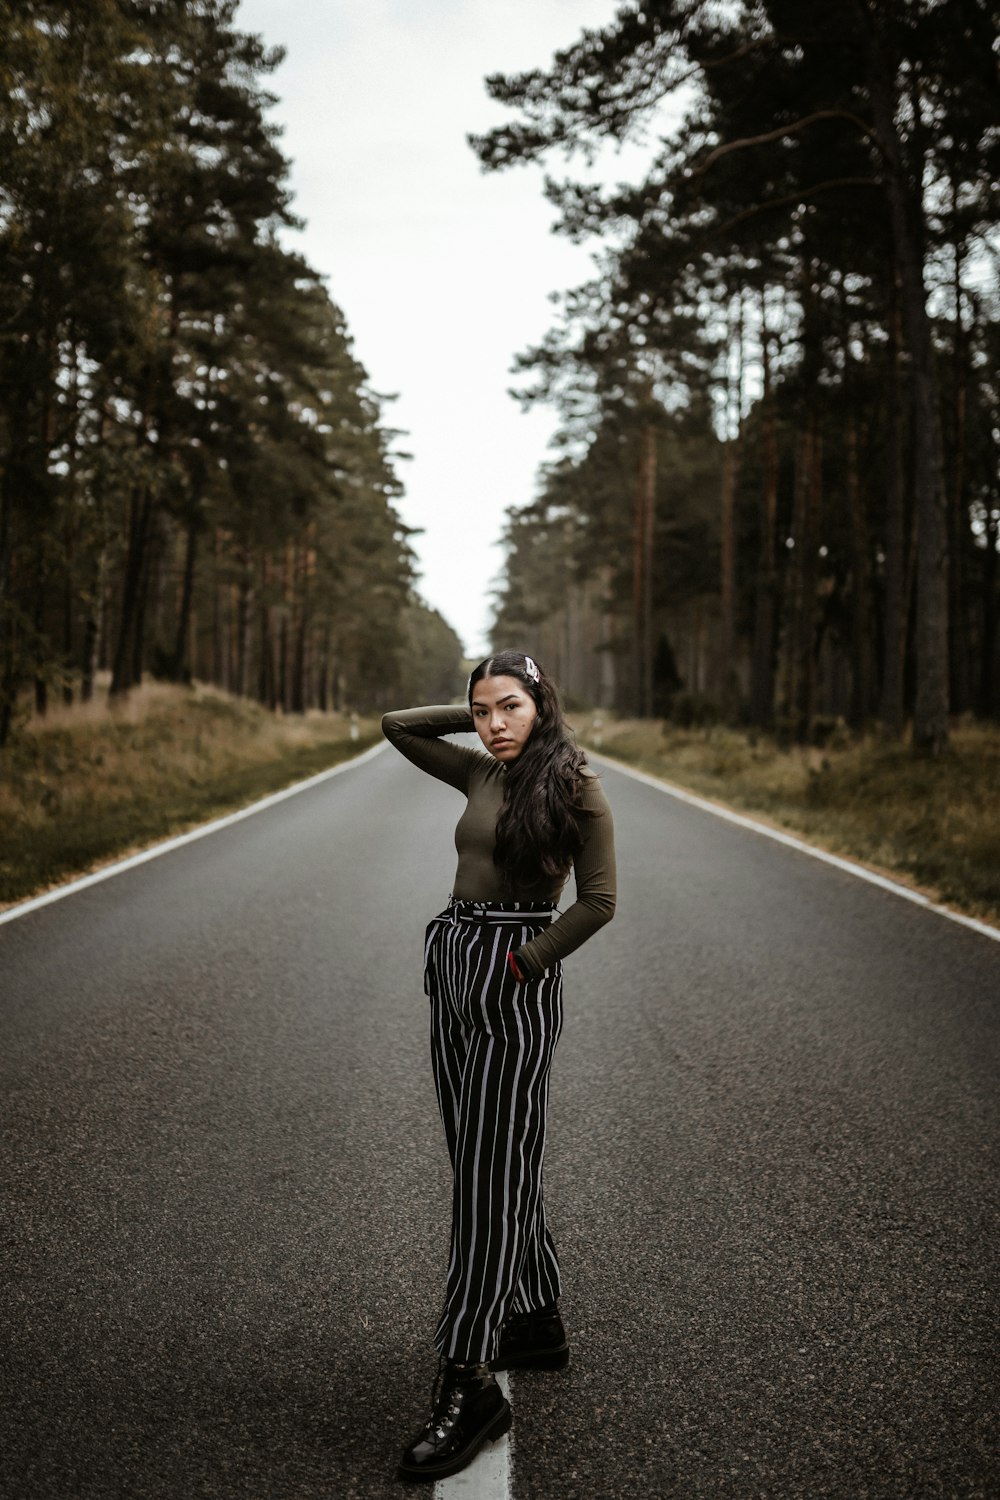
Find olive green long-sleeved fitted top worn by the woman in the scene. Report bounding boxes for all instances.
[382,704,615,978]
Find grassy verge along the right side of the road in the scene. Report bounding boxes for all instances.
[577,716,1000,926]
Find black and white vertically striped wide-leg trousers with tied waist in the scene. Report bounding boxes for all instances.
[424,899,562,1362]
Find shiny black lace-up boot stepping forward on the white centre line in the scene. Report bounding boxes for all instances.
[399,1359,513,1479]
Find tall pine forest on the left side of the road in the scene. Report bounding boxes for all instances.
[0,0,460,746]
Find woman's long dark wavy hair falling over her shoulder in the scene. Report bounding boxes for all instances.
[469,651,588,890]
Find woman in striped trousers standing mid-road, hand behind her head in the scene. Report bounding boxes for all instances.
[382,651,615,1481]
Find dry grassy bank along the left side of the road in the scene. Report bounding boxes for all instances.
[0,684,378,906]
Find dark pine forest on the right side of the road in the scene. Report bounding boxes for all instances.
[471,0,1000,755]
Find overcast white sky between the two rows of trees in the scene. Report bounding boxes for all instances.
[238,0,638,656]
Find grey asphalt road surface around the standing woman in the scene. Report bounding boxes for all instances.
[0,750,1000,1500]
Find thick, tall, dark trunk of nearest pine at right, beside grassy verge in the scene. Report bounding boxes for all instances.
[862,11,949,755]
